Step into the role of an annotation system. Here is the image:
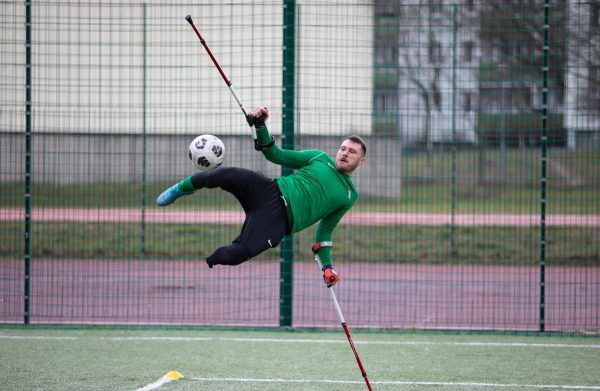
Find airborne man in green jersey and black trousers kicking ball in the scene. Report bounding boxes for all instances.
[156,107,367,287]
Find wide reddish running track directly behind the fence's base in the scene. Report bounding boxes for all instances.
[0,259,600,333]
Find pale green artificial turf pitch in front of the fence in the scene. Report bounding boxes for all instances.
[0,327,600,391]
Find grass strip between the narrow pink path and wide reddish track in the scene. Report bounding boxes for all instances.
[0,222,600,265]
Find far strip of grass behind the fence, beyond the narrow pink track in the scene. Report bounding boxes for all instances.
[0,148,600,214]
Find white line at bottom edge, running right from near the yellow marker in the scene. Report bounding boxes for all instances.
[187,377,600,390]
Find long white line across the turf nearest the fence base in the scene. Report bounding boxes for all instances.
[0,335,600,349]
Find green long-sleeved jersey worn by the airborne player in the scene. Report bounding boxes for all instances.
[257,127,358,266]
